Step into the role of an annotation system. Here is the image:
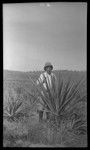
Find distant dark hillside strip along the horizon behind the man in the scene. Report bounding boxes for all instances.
[3,70,86,81]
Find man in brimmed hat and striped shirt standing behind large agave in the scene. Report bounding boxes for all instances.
[37,62,57,121]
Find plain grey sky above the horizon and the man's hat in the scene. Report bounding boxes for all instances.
[3,2,87,71]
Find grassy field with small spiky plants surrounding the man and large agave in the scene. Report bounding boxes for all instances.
[3,70,87,147]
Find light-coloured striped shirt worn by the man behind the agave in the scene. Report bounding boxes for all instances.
[37,72,57,89]
